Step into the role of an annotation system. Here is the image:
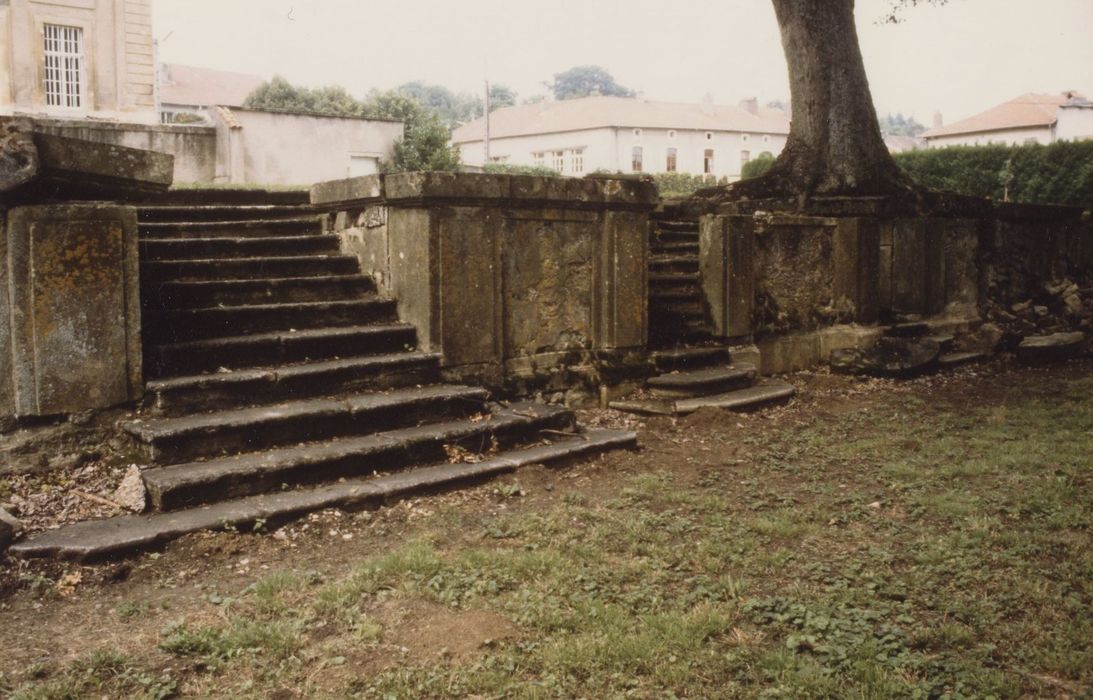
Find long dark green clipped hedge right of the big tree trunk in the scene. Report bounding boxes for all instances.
[895,141,1093,207]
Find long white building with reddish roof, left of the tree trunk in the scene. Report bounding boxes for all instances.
[451,96,789,179]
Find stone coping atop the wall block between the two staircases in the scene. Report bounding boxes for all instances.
[312,172,658,210]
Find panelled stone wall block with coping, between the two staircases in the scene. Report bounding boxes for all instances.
[312,173,657,394]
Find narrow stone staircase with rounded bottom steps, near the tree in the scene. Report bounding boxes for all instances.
[611,211,796,416]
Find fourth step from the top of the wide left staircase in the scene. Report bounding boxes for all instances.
[140,235,339,261]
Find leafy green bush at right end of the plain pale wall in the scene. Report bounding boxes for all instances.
[362,90,459,173]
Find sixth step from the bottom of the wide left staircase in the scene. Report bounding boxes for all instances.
[144,296,396,343]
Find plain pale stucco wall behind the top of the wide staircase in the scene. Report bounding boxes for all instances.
[232,108,402,185]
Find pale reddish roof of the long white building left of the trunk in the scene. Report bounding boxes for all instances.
[451,96,789,143]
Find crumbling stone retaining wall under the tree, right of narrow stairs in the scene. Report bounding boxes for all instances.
[700,202,1093,373]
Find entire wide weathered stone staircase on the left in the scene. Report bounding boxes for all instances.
[13,190,636,559]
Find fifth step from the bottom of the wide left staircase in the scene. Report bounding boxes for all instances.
[145,324,418,376]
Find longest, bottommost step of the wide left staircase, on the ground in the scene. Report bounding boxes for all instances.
[11,430,637,561]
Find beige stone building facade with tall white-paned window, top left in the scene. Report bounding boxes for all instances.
[0,0,156,124]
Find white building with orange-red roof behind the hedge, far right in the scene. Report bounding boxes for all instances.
[922,92,1093,149]
